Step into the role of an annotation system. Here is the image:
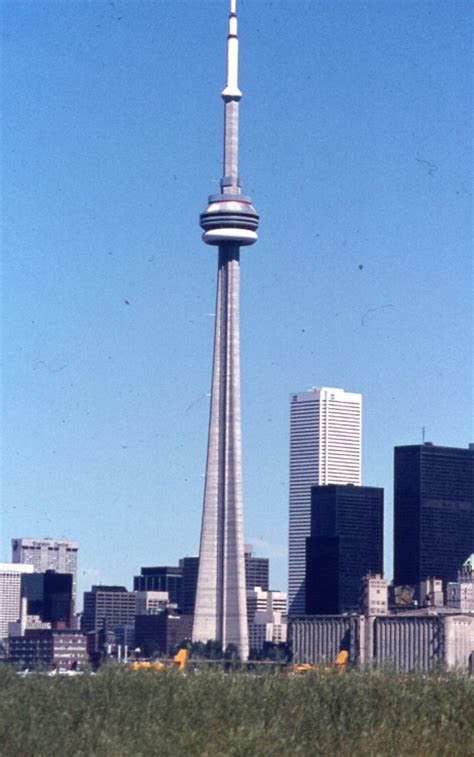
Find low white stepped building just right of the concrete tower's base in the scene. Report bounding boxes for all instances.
[247,586,288,650]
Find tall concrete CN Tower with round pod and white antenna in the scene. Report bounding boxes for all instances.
[193,0,258,660]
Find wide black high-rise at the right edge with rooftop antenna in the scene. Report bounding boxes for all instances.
[394,443,474,591]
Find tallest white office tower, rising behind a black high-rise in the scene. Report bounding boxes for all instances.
[288,386,362,615]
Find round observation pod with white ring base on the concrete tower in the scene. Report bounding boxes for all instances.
[200,194,259,245]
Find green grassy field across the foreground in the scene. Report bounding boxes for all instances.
[0,667,474,757]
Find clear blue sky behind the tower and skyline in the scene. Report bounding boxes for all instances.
[0,0,472,604]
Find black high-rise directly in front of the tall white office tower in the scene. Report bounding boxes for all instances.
[306,484,383,615]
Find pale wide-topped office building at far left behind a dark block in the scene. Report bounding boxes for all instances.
[12,539,79,607]
